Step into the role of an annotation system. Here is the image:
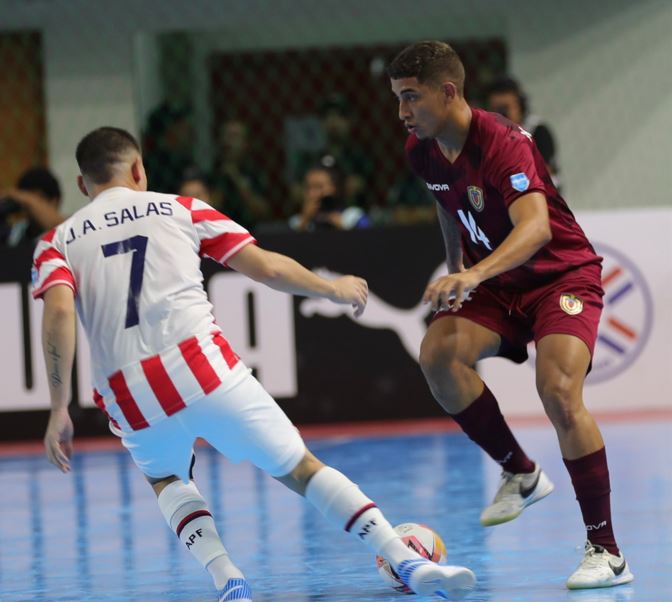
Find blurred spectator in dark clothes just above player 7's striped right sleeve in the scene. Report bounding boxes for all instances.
[212,119,273,229]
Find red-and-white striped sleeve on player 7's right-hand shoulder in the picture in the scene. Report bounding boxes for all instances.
[177,197,257,265]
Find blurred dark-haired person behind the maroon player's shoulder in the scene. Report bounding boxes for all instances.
[487,77,560,186]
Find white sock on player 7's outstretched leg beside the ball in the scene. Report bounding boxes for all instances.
[306,466,420,569]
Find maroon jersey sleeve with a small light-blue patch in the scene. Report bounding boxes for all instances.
[488,130,546,207]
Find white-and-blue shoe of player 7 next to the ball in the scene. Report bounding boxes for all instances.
[396,558,476,600]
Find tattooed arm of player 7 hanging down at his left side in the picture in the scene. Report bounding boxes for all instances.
[42,284,75,472]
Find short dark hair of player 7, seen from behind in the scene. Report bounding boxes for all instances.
[75,126,140,184]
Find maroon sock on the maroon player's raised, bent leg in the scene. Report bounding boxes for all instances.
[451,386,534,474]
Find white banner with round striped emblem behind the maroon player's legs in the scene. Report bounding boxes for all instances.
[479,209,672,416]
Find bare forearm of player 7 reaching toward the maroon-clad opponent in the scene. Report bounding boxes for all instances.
[228,245,369,317]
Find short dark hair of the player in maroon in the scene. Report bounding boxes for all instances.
[387,41,464,94]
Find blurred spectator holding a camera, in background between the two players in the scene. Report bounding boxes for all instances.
[289,165,371,232]
